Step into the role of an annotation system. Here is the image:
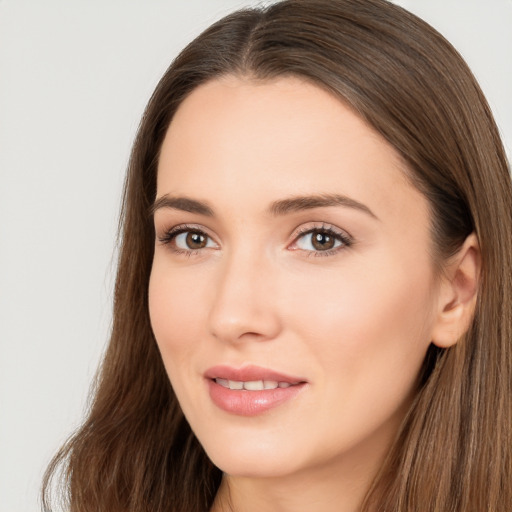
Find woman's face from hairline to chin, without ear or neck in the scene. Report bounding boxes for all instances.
[149,77,437,476]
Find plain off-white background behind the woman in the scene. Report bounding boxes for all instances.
[0,0,512,512]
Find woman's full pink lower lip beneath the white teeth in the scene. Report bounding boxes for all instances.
[208,379,305,416]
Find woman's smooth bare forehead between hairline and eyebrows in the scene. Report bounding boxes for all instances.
[157,76,426,227]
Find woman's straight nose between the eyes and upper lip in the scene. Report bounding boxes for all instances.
[208,248,281,343]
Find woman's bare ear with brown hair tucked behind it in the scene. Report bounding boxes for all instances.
[432,233,481,348]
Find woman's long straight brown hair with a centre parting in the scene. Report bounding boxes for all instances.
[43,0,512,512]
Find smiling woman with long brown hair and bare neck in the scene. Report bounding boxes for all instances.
[45,0,512,512]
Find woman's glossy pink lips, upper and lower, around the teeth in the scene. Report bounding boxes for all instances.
[204,365,307,416]
